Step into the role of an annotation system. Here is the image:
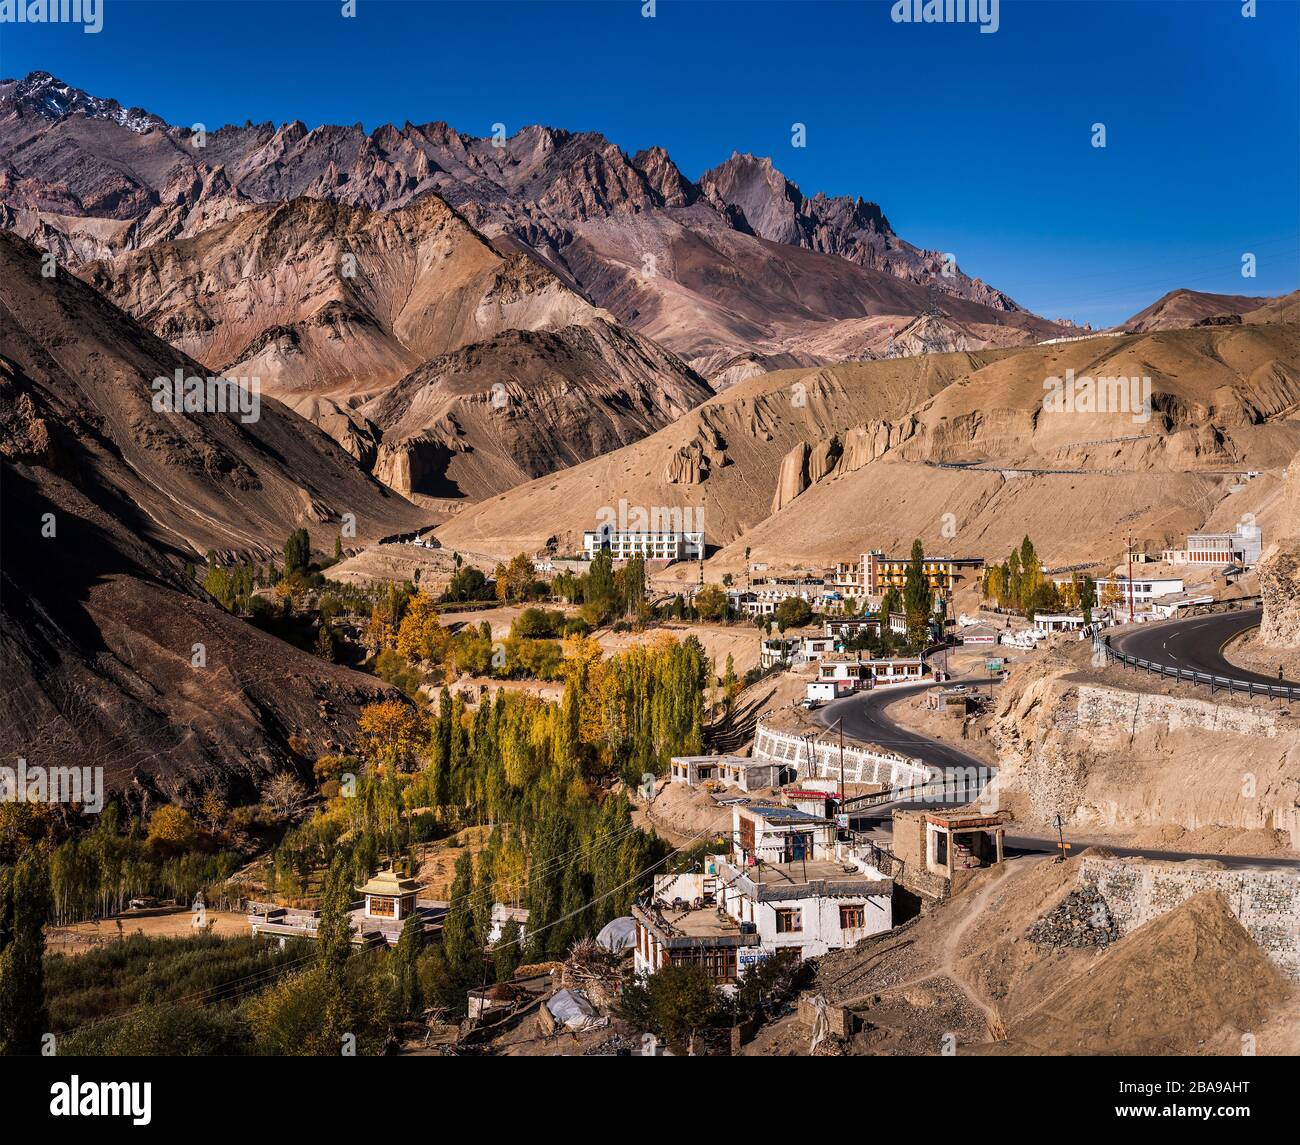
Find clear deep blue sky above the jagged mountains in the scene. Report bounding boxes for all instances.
[0,0,1300,325]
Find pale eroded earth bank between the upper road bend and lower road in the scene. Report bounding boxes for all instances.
[989,652,1300,847]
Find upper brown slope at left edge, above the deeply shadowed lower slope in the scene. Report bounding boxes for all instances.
[0,224,429,558]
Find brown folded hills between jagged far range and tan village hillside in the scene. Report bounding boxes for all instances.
[73,195,711,498]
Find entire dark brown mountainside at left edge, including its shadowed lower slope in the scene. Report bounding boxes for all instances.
[0,233,428,804]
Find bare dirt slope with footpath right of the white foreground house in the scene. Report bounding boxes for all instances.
[742,851,1297,1057]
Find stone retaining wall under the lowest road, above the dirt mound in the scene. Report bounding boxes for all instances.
[1079,858,1300,979]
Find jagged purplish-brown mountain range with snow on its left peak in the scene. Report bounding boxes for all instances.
[0,73,1061,382]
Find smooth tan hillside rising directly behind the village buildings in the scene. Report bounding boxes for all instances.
[439,325,1300,572]
